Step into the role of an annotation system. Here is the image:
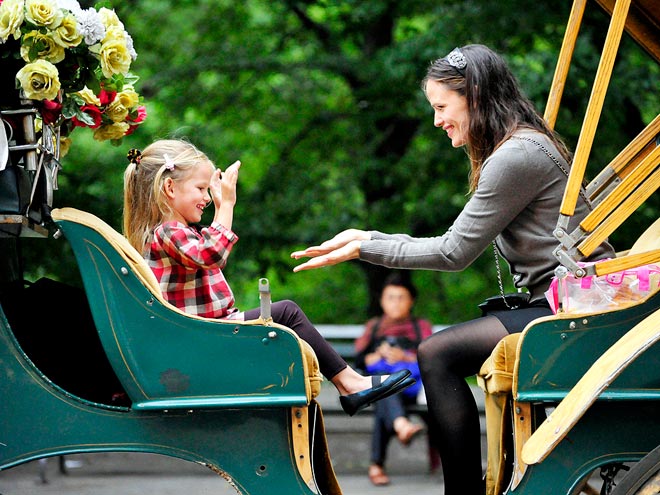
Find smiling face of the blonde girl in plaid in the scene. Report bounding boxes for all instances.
[165,162,213,225]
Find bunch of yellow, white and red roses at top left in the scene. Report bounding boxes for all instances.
[0,0,146,156]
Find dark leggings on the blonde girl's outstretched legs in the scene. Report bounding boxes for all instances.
[244,300,348,380]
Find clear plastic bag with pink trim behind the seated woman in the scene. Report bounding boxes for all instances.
[545,263,660,314]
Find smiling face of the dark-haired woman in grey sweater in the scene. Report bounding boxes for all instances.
[426,80,469,148]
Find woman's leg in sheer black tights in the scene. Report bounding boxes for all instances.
[417,316,508,495]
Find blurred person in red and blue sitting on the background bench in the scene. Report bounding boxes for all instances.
[355,272,437,486]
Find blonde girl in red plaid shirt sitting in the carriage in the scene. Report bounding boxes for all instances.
[124,140,415,416]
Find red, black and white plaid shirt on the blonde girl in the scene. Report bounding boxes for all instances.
[145,222,238,318]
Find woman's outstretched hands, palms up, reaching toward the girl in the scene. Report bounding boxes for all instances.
[291,229,371,272]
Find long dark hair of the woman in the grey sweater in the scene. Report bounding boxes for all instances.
[422,45,572,192]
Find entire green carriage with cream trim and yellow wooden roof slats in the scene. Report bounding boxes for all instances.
[0,0,660,495]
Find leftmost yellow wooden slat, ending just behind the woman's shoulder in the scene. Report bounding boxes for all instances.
[543,0,587,129]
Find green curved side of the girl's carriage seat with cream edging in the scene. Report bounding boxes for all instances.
[52,208,322,409]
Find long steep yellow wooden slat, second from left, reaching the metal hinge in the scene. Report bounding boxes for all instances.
[560,0,631,217]
